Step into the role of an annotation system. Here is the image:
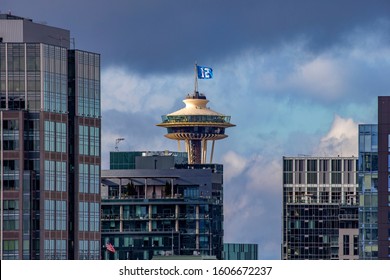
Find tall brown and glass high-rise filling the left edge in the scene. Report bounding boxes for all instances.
[0,14,101,259]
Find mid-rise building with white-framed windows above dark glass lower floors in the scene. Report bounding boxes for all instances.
[282,156,359,260]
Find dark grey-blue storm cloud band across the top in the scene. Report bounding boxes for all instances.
[0,0,390,72]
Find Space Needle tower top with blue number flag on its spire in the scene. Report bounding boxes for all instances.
[157,64,235,164]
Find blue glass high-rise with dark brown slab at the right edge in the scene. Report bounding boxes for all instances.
[359,96,390,260]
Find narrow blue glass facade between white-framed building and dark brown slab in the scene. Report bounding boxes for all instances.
[358,124,378,260]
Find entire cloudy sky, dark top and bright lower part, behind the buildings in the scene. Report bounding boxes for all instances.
[0,0,390,259]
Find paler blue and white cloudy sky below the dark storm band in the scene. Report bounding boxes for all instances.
[97,25,390,259]
